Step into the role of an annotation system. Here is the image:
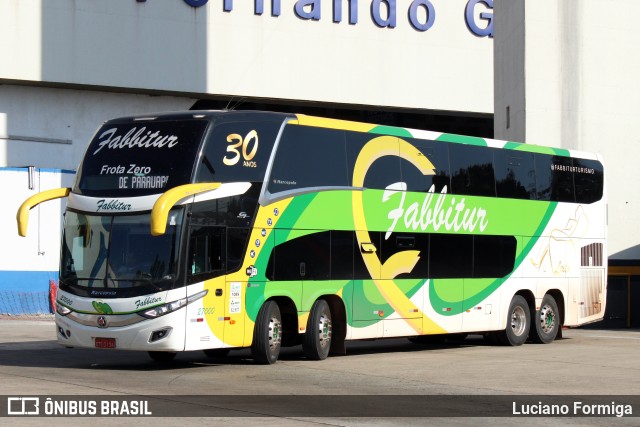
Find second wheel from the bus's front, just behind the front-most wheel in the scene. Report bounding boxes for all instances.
[302,299,333,360]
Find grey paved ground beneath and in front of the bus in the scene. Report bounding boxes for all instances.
[0,318,640,426]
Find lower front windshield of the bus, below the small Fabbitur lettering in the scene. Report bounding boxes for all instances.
[60,209,183,297]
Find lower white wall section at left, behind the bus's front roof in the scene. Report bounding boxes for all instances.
[0,85,194,170]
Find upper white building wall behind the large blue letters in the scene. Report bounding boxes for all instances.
[0,0,493,113]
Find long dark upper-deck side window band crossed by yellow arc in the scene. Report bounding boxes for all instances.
[268,125,604,203]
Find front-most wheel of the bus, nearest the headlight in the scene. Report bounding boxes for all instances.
[251,301,282,365]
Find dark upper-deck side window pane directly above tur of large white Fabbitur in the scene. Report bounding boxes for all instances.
[449,144,496,197]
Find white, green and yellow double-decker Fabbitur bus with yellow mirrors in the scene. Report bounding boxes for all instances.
[18,111,607,364]
